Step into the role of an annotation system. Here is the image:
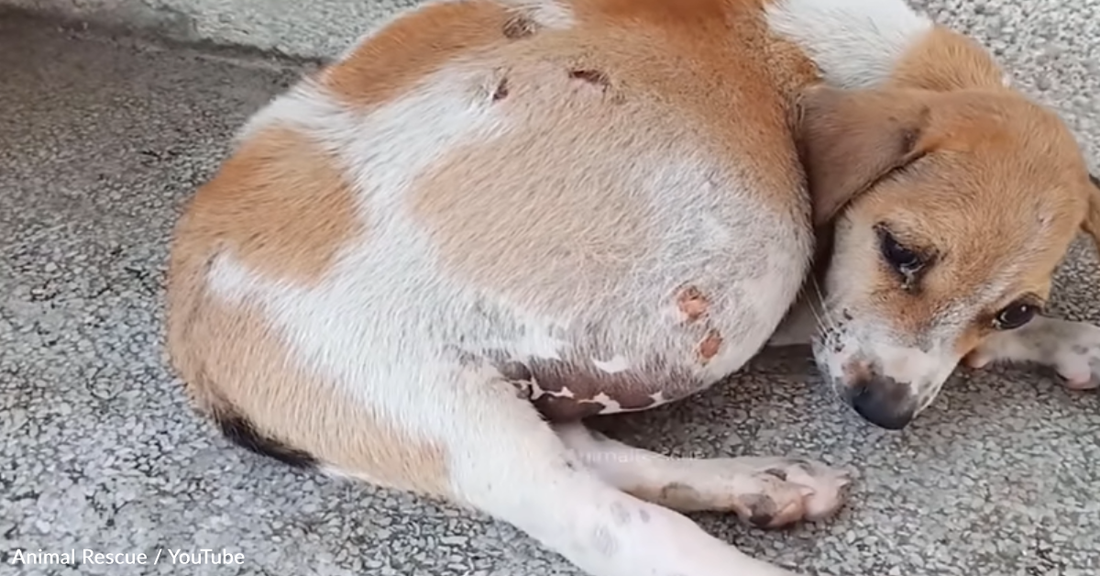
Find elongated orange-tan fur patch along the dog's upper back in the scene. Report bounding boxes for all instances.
[321,0,517,108]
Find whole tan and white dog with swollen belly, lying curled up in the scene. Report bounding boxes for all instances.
[167,0,1100,576]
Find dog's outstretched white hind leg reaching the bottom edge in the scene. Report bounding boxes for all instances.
[448,364,793,576]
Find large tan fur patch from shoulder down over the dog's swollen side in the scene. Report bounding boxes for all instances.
[411,0,815,311]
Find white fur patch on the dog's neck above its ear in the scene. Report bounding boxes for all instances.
[767,0,933,88]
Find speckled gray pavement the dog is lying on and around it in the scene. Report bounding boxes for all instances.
[0,0,1100,576]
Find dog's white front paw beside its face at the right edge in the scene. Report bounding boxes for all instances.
[967,317,1100,390]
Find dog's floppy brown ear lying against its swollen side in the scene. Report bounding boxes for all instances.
[796,86,932,226]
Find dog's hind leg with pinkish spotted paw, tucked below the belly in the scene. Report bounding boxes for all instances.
[557,424,850,528]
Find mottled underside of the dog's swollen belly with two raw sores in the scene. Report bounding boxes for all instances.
[487,258,800,421]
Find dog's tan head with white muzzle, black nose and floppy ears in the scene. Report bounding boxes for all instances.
[800,82,1100,429]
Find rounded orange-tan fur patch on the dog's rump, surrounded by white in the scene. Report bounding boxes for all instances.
[177,128,365,285]
